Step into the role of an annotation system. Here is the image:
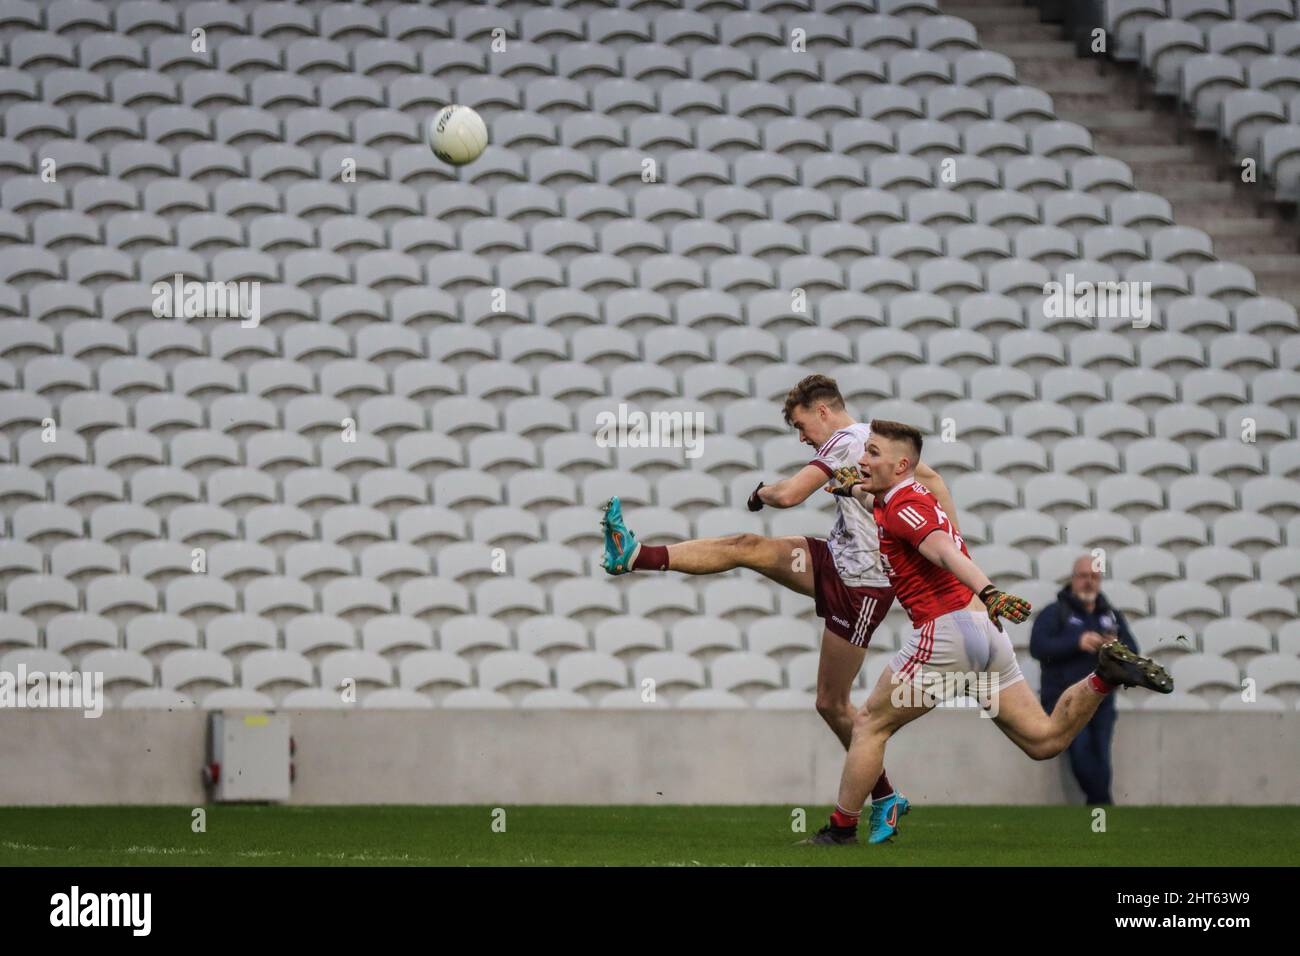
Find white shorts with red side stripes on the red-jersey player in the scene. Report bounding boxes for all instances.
[889,610,1024,706]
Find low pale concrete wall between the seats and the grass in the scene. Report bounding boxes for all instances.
[0,710,1300,806]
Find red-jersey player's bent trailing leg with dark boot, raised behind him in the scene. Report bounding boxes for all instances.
[993,641,1174,760]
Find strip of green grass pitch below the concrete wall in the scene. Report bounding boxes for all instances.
[0,805,1300,866]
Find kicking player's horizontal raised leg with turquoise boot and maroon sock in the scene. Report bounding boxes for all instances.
[601,497,813,596]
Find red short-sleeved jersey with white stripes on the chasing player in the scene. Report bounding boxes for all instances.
[874,481,974,627]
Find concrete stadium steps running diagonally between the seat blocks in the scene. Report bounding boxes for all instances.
[967,0,1300,307]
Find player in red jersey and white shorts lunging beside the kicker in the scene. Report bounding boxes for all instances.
[809,420,1174,844]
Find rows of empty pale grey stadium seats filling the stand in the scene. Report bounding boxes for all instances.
[0,0,1300,709]
